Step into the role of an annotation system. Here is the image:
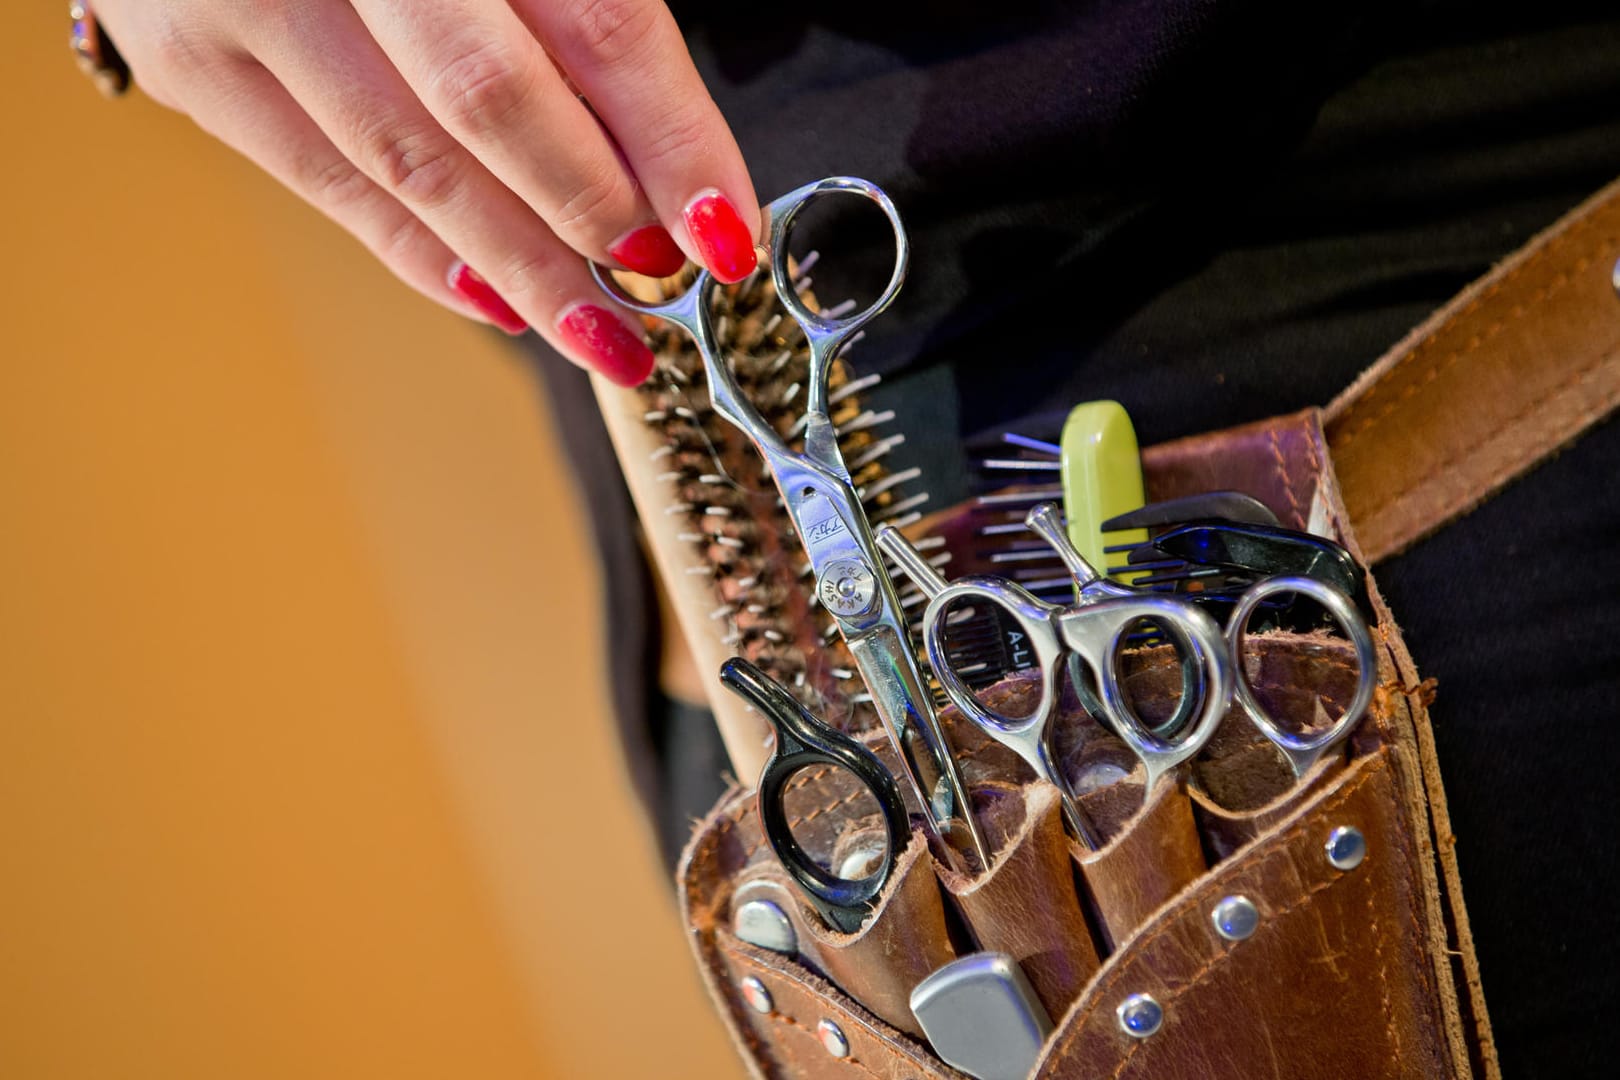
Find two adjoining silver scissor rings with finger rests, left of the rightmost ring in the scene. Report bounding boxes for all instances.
[878,504,1233,850]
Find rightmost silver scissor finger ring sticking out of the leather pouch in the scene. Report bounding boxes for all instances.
[1226,576,1379,777]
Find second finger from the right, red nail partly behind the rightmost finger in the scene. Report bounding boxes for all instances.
[355,0,685,277]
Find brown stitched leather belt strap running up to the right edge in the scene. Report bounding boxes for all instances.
[1324,181,1620,562]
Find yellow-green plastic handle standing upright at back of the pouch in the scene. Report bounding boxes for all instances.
[1059,402,1147,583]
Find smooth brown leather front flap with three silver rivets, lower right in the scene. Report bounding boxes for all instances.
[1035,748,1453,1080]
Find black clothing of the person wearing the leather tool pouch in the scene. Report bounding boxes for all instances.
[524,0,1620,1077]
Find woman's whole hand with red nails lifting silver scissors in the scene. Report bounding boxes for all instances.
[96,0,760,385]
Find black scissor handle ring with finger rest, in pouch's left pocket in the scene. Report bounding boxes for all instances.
[719,657,910,934]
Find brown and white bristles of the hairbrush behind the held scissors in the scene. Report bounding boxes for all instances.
[642,253,948,730]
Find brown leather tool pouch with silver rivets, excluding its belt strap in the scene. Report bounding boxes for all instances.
[680,410,1489,1080]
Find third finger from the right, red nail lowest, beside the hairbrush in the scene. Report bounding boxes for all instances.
[238,5,653,384]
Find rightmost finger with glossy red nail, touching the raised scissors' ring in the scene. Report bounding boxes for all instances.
[512,0,760,282]
